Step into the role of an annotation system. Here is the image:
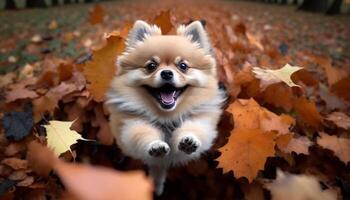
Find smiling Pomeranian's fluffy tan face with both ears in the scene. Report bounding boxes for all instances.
[111,21,217,118]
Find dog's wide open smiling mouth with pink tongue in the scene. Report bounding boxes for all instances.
[144,84,187,110]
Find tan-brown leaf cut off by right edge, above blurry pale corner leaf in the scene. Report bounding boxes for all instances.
[317,132,350,164]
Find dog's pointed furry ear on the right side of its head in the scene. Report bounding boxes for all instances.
[177,21,213,54]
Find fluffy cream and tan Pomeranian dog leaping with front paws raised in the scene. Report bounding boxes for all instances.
[106,21,225,195]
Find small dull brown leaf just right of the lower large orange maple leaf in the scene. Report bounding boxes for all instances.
[278,136,313,155]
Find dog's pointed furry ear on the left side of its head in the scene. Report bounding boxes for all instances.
[126,20,162,47]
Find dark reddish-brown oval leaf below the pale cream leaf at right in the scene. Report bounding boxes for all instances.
[294,97,322,129]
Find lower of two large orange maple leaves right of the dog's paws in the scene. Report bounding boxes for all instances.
[217,128,275,182]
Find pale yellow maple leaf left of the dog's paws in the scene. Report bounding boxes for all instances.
[43,120,87,156]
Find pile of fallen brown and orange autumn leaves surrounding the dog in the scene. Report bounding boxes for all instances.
[0,1,350,199]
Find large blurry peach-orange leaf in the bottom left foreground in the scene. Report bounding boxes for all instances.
[29,142,153,200]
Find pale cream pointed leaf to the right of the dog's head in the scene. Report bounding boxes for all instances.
[252,64,302,88]
